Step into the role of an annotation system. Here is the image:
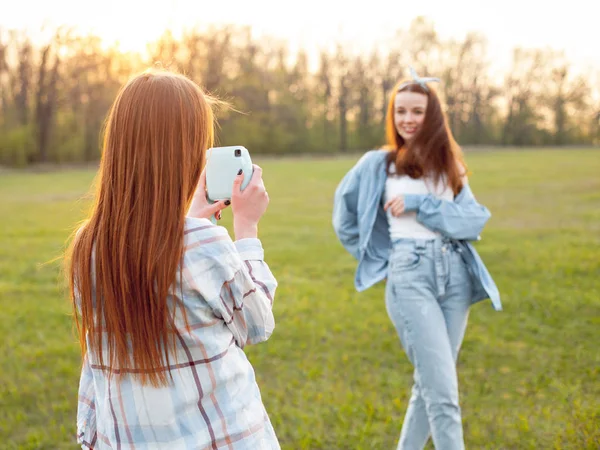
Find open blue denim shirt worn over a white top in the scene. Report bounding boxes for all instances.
[333,150,502,311]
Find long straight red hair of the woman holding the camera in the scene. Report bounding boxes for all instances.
[67,71,214,386]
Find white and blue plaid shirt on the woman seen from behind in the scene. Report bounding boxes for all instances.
[77,218,280,450]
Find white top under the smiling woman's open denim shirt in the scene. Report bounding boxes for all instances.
[384,163,454,241]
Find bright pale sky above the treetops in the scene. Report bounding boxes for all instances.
[0,0,600,75]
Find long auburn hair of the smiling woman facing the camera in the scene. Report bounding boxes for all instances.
[386,80,467,195]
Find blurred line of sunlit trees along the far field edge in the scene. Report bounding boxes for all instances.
[0,18,600,166]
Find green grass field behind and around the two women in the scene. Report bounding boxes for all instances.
[0,150,600,449]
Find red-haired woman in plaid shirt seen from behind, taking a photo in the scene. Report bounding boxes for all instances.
[67,71,279,450]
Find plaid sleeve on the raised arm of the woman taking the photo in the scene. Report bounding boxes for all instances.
[183,225,277,348]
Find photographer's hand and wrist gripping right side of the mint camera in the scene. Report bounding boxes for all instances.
[231,164,269,240]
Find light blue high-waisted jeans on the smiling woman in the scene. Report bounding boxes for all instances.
[386,238,472,450]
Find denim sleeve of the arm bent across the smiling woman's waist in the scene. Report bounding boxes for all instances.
[404,184,491,241]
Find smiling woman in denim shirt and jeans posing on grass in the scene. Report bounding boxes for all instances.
[333,69,501,450]
